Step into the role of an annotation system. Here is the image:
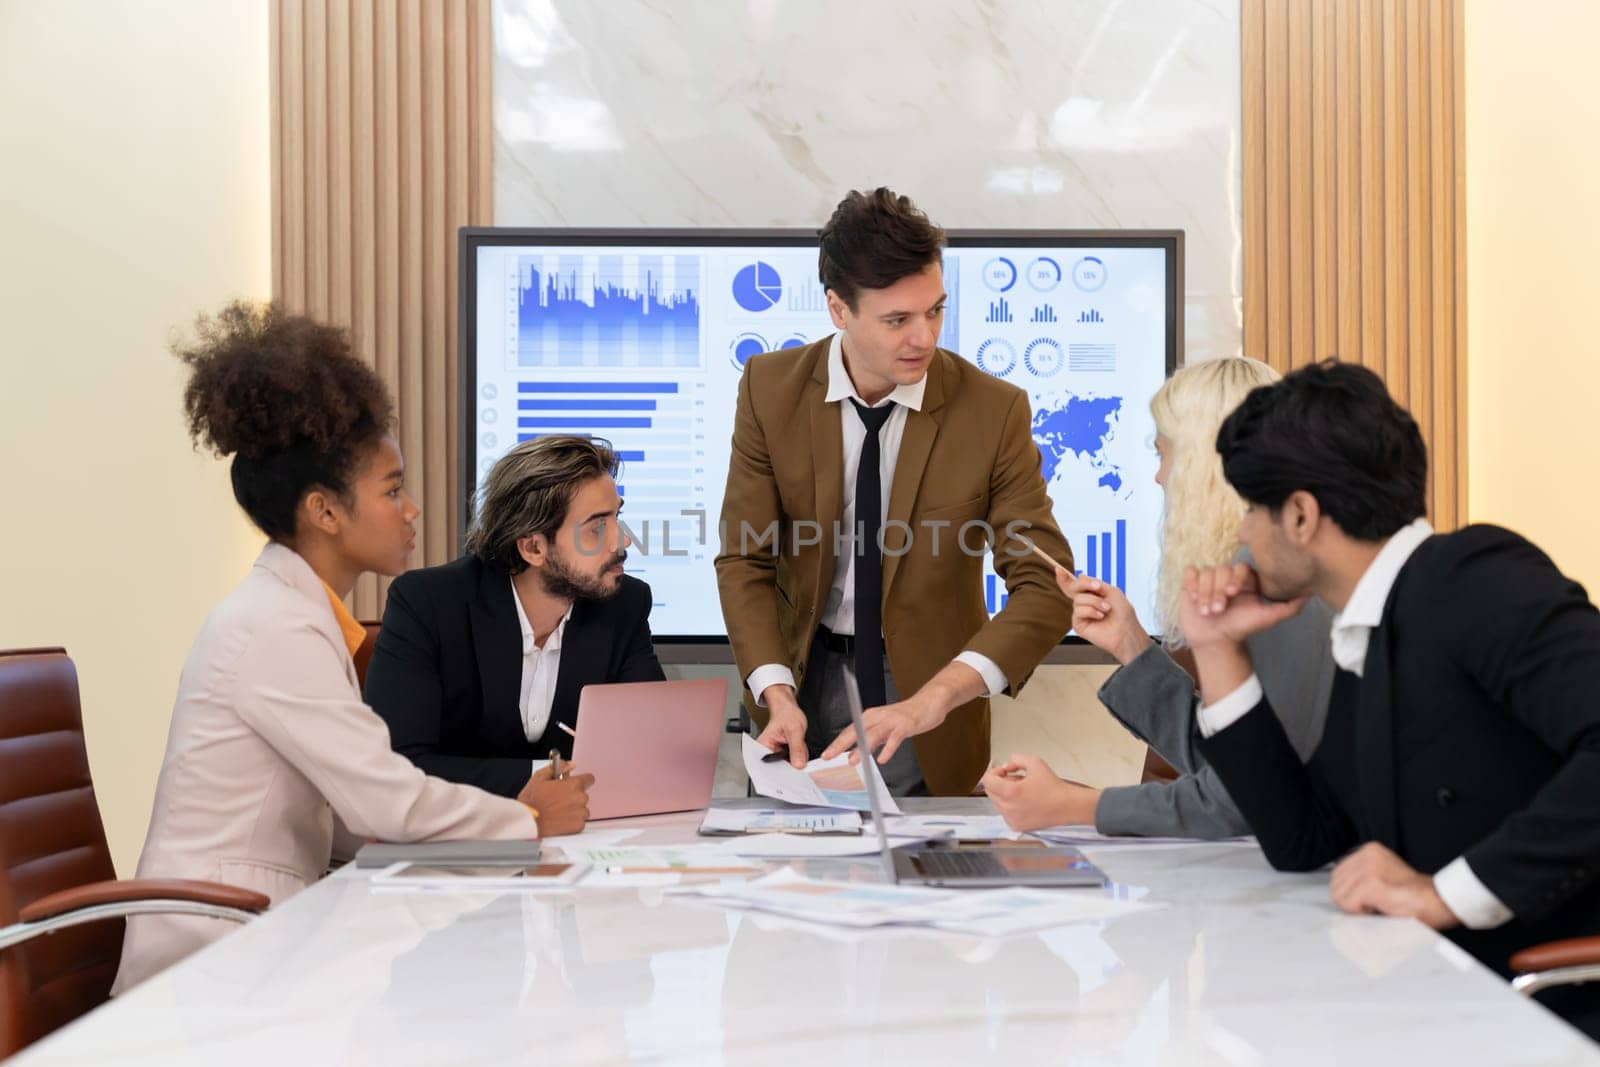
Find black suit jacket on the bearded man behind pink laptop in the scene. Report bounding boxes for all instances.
[366,555,666,797]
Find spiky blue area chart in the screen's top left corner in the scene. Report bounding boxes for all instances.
[517,254,701,366]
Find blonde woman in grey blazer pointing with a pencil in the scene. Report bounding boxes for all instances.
[984,358,1333,838]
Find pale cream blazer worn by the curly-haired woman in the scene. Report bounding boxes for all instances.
[112,544,538,993]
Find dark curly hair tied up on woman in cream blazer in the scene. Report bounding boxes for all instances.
[173,301,394,541]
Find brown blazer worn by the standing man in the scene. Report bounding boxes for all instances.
[717,336,1072,795]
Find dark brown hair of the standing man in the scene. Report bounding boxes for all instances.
[818,187,944,310]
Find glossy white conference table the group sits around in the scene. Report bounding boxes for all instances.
[13,800,1600,1067]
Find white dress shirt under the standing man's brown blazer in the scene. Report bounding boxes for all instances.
[746,333,1008,707]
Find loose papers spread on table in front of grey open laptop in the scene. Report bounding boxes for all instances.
[669,870,1147,937]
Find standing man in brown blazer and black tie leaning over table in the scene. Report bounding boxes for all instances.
[717,189,1072,795]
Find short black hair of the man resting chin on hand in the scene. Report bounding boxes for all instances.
[1216,360,1427,541]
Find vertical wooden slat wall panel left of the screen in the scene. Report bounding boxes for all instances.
[270,0,493,617]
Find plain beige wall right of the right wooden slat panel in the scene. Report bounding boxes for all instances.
[1466,0,1600,597]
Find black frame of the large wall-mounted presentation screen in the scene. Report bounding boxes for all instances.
[456,226,1184,648]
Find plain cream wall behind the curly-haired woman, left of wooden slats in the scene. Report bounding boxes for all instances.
[0,0,270,875]
